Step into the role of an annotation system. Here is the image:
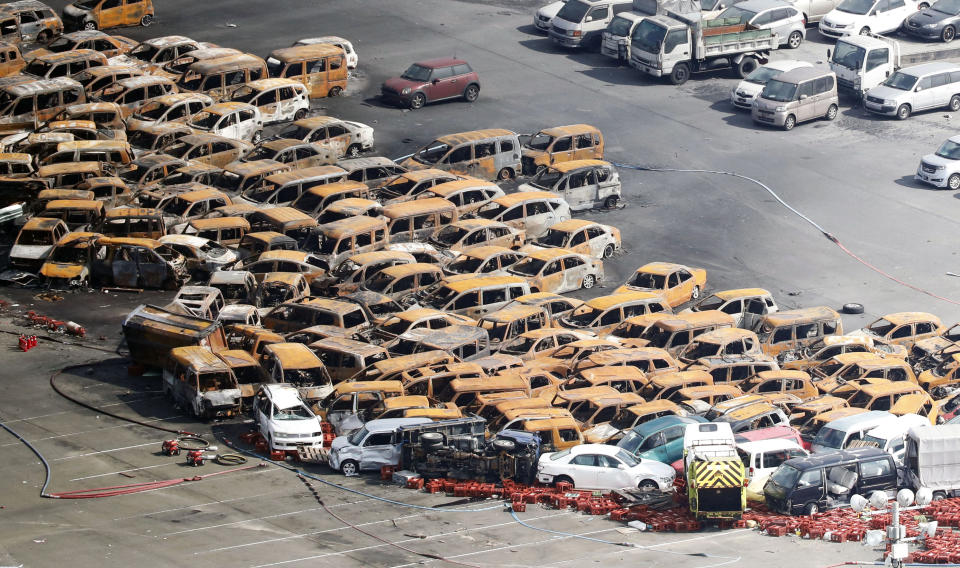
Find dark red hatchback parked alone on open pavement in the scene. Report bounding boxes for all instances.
[380,57,480,109]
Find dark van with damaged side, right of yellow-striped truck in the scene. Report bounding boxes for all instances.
[763,448,899,515]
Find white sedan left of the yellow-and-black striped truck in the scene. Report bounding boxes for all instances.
[537,444,676,491]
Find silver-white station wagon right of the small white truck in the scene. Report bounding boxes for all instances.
[863,61,960,120]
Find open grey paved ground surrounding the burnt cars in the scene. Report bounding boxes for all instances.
[0,0,960,568]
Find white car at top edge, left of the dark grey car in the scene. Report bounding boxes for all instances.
[819,0,930,38]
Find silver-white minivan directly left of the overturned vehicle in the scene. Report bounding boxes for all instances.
[327,418,432,475]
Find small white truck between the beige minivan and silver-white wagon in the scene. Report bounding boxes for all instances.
[827,34,900,98]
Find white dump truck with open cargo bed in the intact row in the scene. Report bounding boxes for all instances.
[630,0,779,85]
